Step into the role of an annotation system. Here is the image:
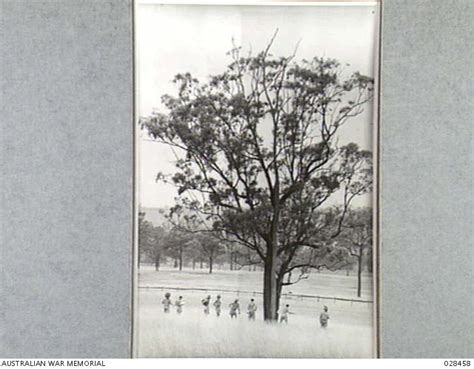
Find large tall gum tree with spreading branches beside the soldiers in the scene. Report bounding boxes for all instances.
[140,36,373,320]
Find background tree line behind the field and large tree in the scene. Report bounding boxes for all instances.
[138,208,372,297]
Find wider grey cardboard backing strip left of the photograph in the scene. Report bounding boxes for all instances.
[0,0,133,358]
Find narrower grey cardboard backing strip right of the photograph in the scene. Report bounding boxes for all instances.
[380,0,474,358]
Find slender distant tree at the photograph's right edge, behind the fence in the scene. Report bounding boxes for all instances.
[339,208,373,297]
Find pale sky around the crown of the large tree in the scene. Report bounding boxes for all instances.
[136,5,377,207]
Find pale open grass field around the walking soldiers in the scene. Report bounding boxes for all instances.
[137,267,373,358]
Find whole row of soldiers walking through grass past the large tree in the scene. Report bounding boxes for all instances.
[161,292,329,328]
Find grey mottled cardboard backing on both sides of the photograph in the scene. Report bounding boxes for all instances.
[0,0,474,358]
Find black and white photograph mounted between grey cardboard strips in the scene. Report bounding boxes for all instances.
[134,1,379,358]
